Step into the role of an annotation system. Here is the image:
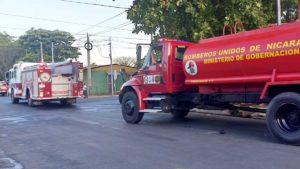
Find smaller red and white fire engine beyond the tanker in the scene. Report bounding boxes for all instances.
[8,61,83,106]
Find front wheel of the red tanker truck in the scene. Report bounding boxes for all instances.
[122,92,144,124]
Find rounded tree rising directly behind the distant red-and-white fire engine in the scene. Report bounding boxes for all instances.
[19,28,80,62]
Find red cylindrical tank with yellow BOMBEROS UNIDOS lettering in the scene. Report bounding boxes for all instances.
[183,22,300,90]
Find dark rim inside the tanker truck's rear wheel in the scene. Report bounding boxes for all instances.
[276,104,300,133]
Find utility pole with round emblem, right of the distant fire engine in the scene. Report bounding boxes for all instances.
[84,33,93,96]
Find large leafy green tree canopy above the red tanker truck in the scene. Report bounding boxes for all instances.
[127,0,297,41]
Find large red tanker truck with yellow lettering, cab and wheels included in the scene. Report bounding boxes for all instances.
[119,22,300,144]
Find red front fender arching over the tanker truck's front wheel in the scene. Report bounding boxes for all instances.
[119,77,148,110]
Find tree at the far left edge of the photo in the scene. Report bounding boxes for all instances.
[0,32,24,80]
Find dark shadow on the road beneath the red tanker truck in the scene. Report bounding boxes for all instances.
[141,113,276,142]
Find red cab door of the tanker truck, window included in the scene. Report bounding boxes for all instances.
[142,45,167,93]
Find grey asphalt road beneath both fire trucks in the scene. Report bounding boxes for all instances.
[0,97,300,169]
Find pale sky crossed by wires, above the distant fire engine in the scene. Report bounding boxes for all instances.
[0,0,150,65]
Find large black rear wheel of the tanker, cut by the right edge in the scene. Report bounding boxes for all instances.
[267,92,300,145]
